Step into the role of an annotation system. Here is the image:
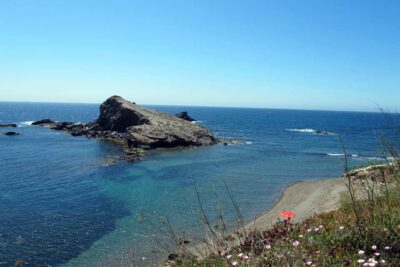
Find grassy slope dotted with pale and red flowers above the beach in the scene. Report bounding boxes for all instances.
[164,165,400,267]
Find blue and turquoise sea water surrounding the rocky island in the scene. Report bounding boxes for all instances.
[0,103,398,266]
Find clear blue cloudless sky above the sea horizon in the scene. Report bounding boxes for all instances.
[0,0,400,110]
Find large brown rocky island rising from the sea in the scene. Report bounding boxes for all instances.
[32,96,217,162]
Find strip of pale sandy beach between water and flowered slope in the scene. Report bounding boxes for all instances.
[246,178,347,230]
